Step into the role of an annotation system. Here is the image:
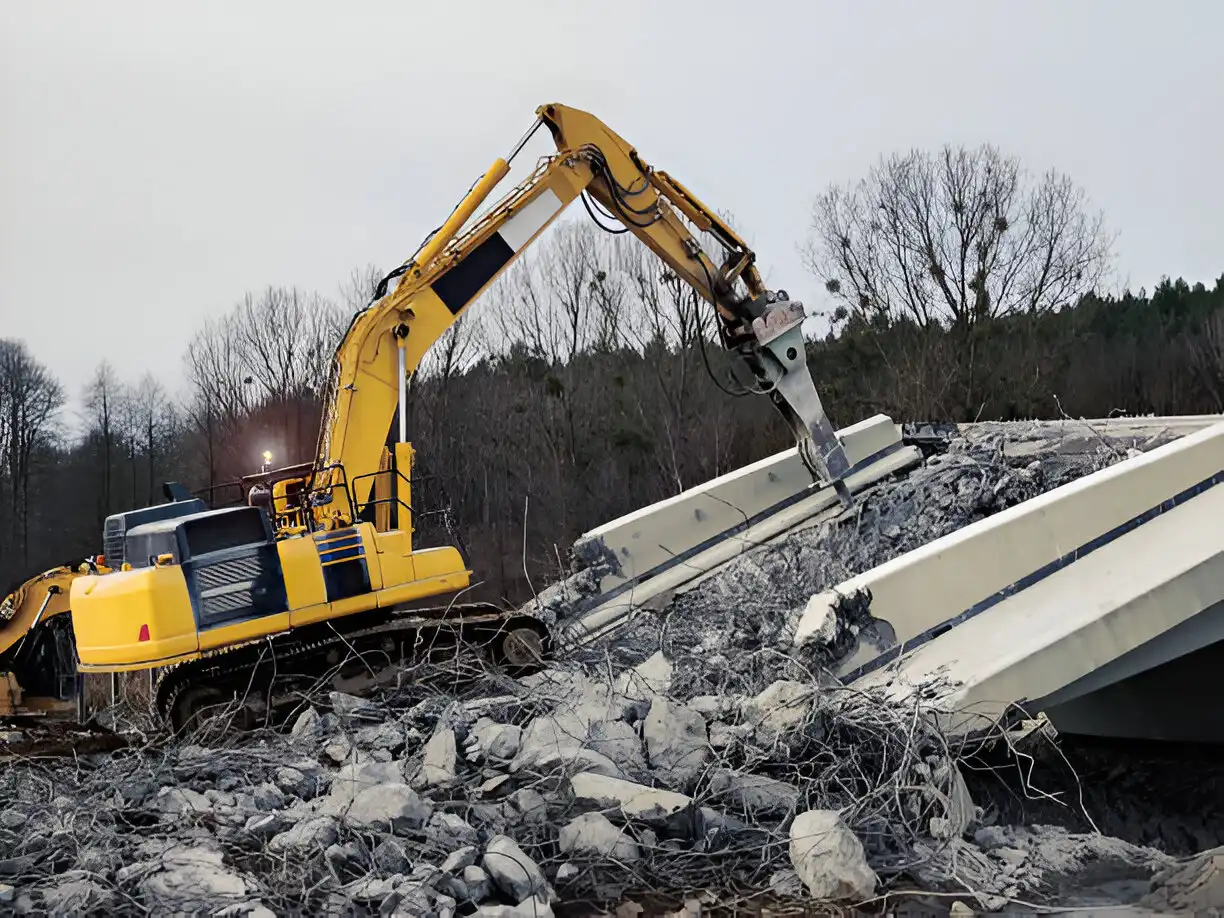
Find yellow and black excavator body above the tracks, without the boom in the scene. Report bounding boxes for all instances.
[71,507,471,672]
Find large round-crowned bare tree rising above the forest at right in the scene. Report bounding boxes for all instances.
[804,146,1113,328]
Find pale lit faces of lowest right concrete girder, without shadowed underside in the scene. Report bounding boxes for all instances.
[853,486,1224,736]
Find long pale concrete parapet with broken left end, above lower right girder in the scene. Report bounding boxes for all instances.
[796,424,1224,678]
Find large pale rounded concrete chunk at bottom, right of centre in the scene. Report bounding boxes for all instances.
[791,809,878,901]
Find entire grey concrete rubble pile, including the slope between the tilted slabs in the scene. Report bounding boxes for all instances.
[0,421,1224,918]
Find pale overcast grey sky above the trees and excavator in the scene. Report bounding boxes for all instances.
[0,0,1224,408]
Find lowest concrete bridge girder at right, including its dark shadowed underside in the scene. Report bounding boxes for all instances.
[854,487,1224,742]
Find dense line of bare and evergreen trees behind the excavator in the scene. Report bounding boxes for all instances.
[0,141,1224,601]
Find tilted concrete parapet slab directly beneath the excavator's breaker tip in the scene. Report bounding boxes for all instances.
[568,415,922,641]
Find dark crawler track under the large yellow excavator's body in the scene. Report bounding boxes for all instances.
[154,603,551,733]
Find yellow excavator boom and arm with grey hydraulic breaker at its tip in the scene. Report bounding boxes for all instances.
[310,104,849,523]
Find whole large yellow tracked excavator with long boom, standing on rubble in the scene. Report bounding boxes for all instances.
[69,104,849,728]
